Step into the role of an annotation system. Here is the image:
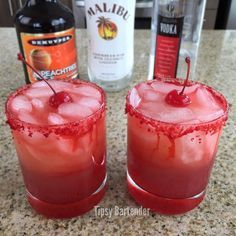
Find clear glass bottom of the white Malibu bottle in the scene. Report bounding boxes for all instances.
[88,68,132,92]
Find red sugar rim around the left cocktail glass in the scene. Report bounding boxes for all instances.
[5,79,106,137]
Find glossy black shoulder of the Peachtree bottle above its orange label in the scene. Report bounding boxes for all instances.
[14,3,75,33]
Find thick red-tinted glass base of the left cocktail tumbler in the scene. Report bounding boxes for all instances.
[27,178,107,219]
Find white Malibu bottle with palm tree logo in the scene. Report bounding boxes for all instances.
[85,0,136,91]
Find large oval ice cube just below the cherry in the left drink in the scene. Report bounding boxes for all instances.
[58,103,93,121]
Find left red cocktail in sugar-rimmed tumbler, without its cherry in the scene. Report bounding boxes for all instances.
[6,80,106,218]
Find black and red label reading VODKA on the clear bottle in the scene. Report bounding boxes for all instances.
[154,15,184,78]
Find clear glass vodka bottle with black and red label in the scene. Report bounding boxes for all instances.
[148,0,206,79]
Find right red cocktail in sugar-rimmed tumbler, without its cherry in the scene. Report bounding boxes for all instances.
[126,79,228,214]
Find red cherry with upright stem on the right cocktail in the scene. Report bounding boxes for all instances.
[165,57,191,107]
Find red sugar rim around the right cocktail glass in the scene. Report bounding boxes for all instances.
[125,78,229,139]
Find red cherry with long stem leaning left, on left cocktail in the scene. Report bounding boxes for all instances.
[17,53,73,108]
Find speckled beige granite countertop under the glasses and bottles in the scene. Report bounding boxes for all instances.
[0,28,236,236]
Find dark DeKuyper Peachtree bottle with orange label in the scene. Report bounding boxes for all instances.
[15,0,78,83]
